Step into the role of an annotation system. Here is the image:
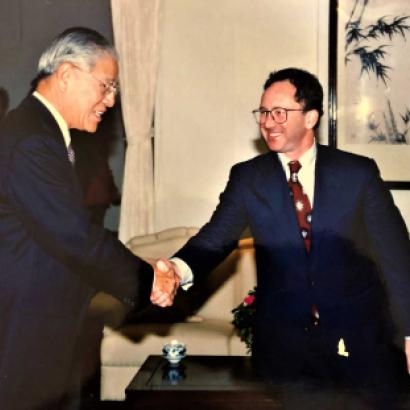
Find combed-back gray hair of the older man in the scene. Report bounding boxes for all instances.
[37,27,118,80]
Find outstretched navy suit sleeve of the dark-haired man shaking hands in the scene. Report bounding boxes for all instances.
[174,165,248,276]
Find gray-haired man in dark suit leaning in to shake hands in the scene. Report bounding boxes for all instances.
[0,28,178,410]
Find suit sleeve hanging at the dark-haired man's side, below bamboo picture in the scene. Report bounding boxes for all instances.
[364,162,410,335]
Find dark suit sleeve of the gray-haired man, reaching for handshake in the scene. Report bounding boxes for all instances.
[5,136,153,305]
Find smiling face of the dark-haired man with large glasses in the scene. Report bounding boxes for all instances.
[260,81,318,160]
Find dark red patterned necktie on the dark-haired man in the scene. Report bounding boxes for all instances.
[288,161,312,252]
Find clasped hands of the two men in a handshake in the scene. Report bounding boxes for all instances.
[150,259,180,307]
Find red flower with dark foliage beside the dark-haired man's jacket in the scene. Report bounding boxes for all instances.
[232,286,256,353]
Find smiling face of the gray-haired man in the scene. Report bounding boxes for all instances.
[66,55,118,132]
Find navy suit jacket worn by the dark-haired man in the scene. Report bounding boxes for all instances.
[175,145,410,380]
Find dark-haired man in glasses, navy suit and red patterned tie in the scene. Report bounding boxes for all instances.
[167,68,410,409]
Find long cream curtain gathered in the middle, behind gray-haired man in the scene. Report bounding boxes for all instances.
[111,0,162,243]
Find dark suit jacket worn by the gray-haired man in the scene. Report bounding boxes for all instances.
[0,96,153,409]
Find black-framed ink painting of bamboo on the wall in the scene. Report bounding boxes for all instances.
[328,0,410,190]
